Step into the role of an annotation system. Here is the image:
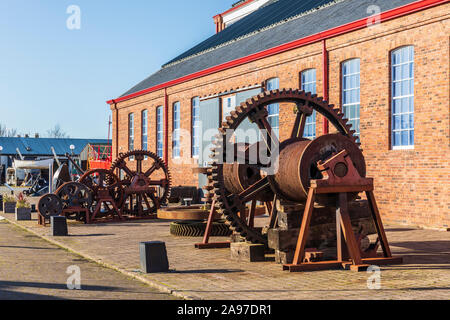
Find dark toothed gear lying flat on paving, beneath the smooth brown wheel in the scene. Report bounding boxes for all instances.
[170,220,231,237]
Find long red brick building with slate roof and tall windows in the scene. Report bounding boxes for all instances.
[108,0,450,228]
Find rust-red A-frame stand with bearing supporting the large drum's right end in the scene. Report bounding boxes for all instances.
[283,150,402,272]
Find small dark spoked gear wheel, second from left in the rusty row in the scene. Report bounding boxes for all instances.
[55,182,92,219]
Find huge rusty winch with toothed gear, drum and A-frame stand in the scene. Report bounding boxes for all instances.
[208,89,400,271]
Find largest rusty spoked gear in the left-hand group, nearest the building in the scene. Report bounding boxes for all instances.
[110,150,172,216]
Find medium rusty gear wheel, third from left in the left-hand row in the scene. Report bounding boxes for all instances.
[79,169,124,215]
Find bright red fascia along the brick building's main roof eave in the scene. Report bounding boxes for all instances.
[107,0,449,104]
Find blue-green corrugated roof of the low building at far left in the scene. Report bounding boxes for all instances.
[0,137,108,157]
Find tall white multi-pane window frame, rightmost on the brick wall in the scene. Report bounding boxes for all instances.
[390,46,415,150]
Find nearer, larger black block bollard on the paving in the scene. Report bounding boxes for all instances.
[139,241,169,273]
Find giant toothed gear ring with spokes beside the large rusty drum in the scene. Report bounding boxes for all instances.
[208,89,365,245]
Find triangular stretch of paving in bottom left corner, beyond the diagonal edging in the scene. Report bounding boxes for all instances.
[0,221,178,300]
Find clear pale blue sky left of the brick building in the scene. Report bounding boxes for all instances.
[0,0,237,138]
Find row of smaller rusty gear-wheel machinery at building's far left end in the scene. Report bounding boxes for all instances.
[38,150,171,225]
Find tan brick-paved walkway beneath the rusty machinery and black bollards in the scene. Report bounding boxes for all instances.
[0,209,450,300]
